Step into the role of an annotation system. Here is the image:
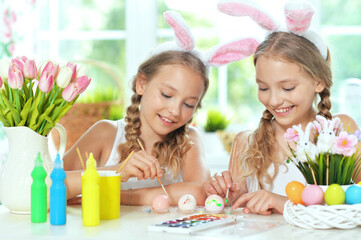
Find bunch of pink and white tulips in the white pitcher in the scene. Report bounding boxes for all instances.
[0,56,91,136]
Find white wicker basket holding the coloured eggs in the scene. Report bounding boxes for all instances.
[283,200,361,229]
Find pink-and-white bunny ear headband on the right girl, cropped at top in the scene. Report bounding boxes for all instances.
[218,0,327,59]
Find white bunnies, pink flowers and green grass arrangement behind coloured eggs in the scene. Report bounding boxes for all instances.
[285,115,361,185]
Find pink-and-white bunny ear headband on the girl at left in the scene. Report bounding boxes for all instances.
[151,11,259,66]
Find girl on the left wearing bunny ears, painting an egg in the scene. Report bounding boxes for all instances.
[64,8,258,205]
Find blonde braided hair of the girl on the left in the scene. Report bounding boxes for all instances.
[118,51,209,176]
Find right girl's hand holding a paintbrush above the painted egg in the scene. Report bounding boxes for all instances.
[204,171,240,199]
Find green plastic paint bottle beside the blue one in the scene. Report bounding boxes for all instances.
[31,152,48,223]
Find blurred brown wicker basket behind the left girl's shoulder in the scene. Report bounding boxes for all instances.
[51,102,115,151]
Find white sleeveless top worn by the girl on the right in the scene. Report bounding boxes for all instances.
[246,162,306,196]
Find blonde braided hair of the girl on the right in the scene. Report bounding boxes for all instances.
[241,32,332,189]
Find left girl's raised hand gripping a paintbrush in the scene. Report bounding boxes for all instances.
[121,151,162,182]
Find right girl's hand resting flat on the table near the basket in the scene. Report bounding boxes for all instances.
[232,190,287,215]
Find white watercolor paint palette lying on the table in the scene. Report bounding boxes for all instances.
[148,213,237,234]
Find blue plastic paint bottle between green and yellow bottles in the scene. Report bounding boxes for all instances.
[50,153,66,225]
